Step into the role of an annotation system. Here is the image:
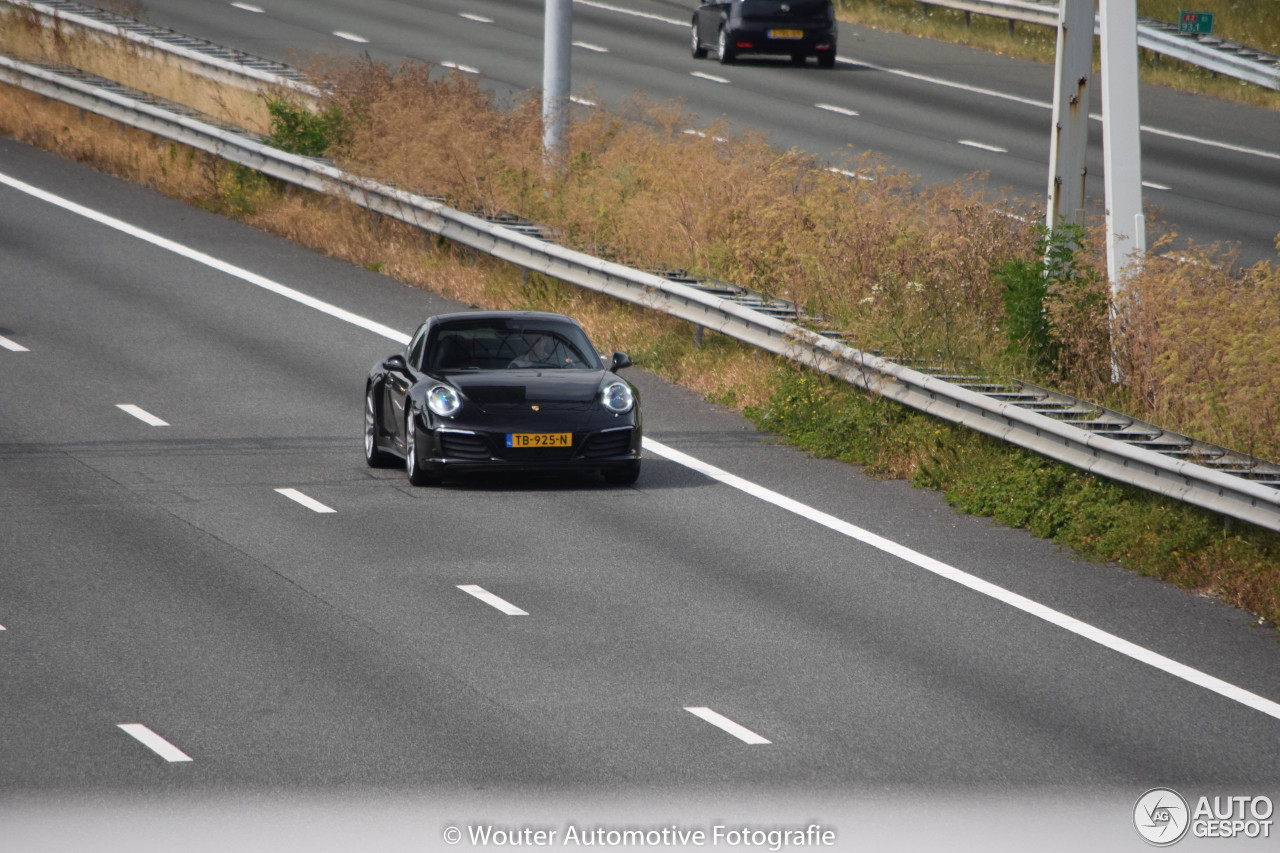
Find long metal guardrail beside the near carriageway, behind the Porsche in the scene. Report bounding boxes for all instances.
[0,46,1280,530]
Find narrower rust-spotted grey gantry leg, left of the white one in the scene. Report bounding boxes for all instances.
[1044,0,1094,231]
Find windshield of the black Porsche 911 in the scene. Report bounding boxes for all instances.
[424,320,600,370]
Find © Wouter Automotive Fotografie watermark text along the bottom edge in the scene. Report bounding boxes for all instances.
[442,824,836,853]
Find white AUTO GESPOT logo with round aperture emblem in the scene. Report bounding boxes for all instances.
[1133,788,1275,847]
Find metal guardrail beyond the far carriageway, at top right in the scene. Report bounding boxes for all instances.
[920,0,1280,90]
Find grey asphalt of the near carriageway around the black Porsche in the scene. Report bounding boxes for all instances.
[0,142,1280,840]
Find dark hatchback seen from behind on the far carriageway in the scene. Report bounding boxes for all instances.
[690,0,836,68]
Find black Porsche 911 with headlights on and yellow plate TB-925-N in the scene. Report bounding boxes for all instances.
[365,311,641,485]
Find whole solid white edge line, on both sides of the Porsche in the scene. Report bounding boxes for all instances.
[12,173,1280,720]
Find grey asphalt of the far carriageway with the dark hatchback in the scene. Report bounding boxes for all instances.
[124,0,1280,261]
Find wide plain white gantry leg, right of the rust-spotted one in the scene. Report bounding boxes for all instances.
[1100,0,1147,382]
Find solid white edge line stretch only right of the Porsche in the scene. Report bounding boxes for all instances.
[644,435,1280,720]
